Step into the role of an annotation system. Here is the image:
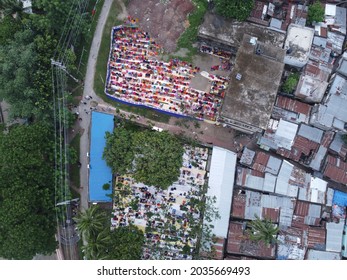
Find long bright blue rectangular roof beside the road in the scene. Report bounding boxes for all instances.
[89,112,113,202]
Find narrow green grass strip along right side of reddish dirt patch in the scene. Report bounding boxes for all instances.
[177,0,208,62]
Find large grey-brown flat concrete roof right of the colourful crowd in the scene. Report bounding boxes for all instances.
[220,34,285,129]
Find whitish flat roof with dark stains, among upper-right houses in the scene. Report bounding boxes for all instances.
[284,24,314,67]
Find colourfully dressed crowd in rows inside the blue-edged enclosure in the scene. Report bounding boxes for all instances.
[106,25,228,121]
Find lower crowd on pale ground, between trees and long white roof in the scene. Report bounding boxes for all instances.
[111,146,208,259]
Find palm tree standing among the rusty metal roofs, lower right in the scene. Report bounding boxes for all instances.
[246,215,279,245]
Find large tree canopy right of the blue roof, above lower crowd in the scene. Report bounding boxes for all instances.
[103,127,184,189]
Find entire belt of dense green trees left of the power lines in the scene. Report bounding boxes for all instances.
[0,0,95,259]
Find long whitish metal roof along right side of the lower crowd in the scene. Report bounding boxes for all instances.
[207,146,237,238]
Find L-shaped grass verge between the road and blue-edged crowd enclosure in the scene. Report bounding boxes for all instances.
[94,1,170,123]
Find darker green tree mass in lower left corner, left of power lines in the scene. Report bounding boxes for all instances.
[0,123,57,259]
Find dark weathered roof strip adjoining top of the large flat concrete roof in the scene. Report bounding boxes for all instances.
[198,12,285,50]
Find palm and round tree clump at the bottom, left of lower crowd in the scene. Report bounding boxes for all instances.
[75,205,144,260]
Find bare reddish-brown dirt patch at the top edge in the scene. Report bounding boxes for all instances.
[127,0,194,52]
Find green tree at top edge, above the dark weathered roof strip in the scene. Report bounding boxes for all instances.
[214,0,254,21]
